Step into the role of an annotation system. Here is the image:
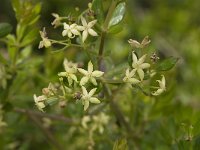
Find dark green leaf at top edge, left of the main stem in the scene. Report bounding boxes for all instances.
[92,0,104,24]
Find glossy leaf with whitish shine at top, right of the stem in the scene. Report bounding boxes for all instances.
[108,2,126,28]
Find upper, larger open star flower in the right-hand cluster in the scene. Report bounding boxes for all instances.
[132,52,150,81]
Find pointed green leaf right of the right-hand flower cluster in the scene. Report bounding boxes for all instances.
[156,57,178,71]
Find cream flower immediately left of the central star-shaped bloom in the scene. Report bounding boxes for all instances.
[58,59,77,85]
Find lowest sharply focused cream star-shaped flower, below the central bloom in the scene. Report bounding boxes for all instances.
[81,86,100,110]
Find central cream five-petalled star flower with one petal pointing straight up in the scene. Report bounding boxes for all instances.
[78,61,104,86]
